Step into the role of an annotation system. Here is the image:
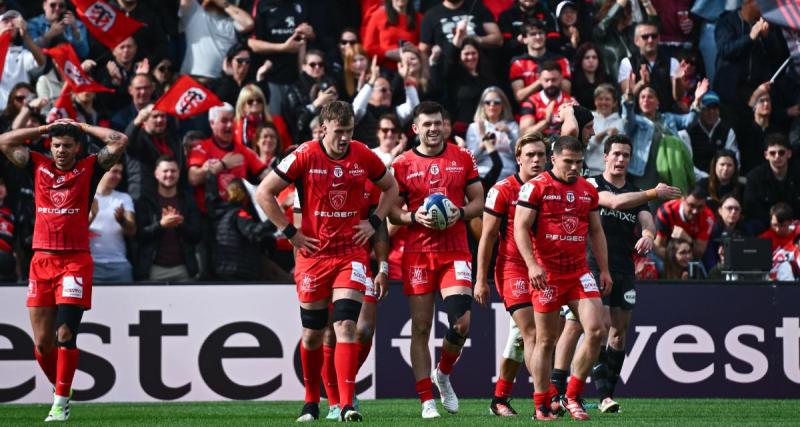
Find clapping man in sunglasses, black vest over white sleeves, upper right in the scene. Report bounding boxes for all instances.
[617,22,684,112]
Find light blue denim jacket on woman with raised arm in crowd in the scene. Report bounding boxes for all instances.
[622,98,697,176]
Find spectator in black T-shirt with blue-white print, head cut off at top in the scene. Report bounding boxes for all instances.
[419,0,503,55]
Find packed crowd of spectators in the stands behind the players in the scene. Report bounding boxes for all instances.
[0,0,800,283]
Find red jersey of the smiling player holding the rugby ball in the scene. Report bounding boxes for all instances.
[392,144,480,253]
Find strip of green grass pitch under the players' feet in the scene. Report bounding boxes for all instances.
[0,399,800,427]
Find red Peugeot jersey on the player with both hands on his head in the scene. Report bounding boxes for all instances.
[28,151,102,252]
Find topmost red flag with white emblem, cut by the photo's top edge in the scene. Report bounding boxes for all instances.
[72,0,144,49]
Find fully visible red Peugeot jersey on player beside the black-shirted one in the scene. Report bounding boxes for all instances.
[517,171,599,274]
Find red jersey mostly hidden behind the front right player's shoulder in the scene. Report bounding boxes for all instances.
[483,174,525,271]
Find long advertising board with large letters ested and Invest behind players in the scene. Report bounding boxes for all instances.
[0,283,800,403]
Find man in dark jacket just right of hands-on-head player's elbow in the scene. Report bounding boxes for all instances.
[125,104,186,202]
